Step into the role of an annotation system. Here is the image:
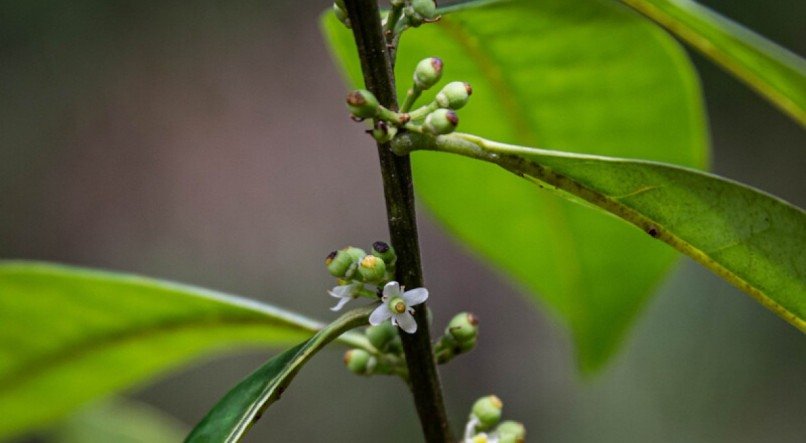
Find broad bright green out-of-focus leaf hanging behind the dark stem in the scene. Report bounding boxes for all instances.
[325,0,707,370]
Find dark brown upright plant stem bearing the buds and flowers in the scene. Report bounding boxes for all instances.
[344,0,453,443]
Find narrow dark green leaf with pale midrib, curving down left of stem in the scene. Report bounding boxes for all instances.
[185,305,375,442]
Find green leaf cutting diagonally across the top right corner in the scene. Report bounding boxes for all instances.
[621,0,806,125]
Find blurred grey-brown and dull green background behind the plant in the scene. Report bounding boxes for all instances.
[0,0,806,442]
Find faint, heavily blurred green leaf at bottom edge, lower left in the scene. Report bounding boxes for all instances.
[55,399,187,443]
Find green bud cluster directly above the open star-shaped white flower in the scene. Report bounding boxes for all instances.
[325,241,397,311]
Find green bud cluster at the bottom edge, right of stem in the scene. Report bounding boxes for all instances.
[464,395,526,443]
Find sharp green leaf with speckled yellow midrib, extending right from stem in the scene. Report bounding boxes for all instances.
[394,134,806,332]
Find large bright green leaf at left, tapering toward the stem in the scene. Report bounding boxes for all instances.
[0,262,366,439]
